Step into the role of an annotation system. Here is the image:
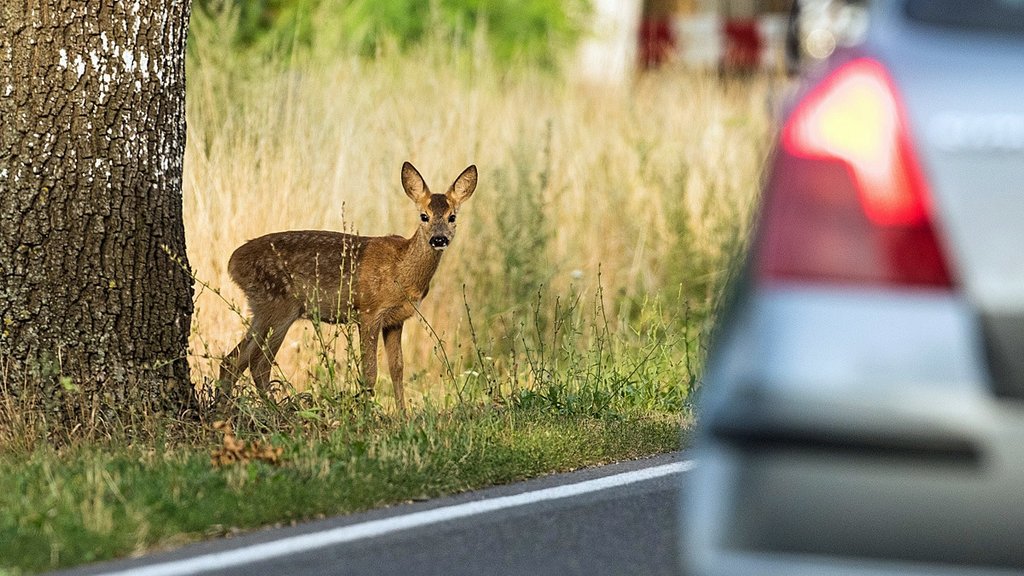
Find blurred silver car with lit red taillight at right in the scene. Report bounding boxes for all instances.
[681,0,1024,576]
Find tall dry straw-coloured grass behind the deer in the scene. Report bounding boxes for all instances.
[184,14,770,403]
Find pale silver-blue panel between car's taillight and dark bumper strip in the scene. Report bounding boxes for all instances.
[703,284,987,398]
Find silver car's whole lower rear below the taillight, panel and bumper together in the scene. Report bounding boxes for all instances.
[682,288,1024,576]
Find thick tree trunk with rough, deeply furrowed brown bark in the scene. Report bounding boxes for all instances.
[0,0,193,424]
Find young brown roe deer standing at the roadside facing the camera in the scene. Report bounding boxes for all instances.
[219,162,476,411]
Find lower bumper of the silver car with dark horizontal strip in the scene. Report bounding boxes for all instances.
[683,398,1024,575]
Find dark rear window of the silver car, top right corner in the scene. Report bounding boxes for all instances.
[906,0,1024,34]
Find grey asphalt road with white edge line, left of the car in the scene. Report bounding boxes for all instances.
[60,453,692,576]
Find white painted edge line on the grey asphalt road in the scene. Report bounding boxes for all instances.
[96,460,695,576]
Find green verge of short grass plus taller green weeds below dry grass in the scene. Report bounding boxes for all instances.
[0,278,699,574]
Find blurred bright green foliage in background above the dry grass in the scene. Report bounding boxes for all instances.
[193,0,590,67]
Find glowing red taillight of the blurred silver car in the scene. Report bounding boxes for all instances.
[754,58,952,287]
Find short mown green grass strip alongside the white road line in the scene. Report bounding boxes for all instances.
[0,405,680,574]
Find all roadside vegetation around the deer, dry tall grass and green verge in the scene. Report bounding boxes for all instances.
[0,0,769,574]
